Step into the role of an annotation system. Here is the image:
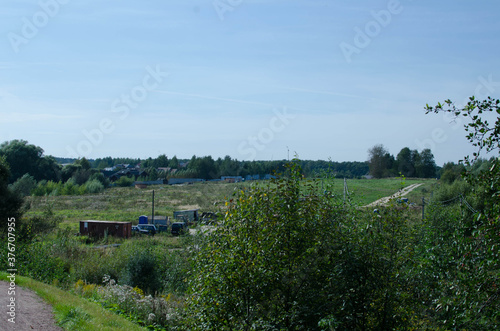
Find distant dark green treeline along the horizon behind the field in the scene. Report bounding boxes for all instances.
[4,140,468,191]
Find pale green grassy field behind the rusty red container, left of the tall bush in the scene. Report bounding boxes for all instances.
[27,183,240,231]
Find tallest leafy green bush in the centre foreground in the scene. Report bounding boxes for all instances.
[189,162,342,330]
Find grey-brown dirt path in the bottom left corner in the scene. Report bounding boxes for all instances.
[0,281,62,331]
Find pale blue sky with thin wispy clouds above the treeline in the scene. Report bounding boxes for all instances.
[0,0,500,165]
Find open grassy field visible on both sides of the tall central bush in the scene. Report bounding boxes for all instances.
[27,178,436,230]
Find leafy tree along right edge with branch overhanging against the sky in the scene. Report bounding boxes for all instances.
[426,97,500,330]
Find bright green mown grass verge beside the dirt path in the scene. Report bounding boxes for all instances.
[0,272,145,331]
